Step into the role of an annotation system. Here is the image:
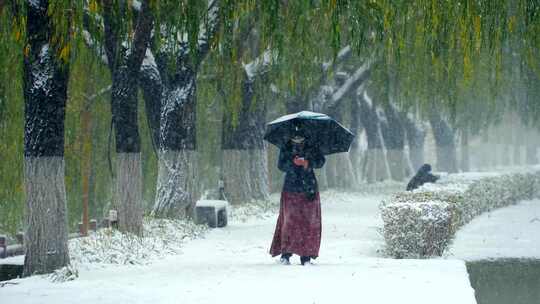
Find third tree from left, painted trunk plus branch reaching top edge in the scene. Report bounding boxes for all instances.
[152,0,219,218]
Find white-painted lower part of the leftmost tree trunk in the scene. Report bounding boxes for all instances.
[23,156,69,276]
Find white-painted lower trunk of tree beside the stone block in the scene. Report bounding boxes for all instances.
[152,150,198,218]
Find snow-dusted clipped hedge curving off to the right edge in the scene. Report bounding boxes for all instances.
[381,172,540,258]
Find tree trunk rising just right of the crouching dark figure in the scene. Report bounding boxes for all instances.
[429,108,458,173]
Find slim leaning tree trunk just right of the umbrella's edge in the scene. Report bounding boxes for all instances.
[357,90,389,183]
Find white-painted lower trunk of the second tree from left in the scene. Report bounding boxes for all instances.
[115,153,144,236]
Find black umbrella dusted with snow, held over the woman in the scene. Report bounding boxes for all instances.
[264,111,354,155]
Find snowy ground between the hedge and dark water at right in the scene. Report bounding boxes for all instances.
[446,200,540,261]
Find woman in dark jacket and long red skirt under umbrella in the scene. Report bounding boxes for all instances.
[270,133,325,265]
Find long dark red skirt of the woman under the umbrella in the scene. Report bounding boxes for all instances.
[270,192,322,258]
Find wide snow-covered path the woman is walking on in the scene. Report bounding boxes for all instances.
[0,193,476,304]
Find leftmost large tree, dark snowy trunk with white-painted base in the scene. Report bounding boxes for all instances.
[23,0,69,276]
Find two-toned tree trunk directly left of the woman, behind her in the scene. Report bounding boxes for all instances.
[222,77,269,204]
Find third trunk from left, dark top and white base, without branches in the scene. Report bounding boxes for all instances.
[152,72,198,218]
